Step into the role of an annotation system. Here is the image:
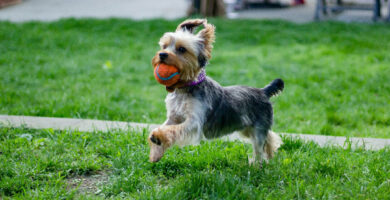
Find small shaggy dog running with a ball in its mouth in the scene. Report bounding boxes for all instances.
[148,19,284,166]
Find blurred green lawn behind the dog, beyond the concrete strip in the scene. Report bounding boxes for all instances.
[0,19,390,138]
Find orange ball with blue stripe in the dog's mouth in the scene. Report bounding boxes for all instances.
[154,63,180,87]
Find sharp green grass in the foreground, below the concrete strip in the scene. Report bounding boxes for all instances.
[0,127,390,199]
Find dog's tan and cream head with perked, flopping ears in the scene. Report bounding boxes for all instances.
[152,19,215,90]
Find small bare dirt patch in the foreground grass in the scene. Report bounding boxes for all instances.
[67,172,108,195]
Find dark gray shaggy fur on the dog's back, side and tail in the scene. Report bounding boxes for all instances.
[186,77,284,140]
